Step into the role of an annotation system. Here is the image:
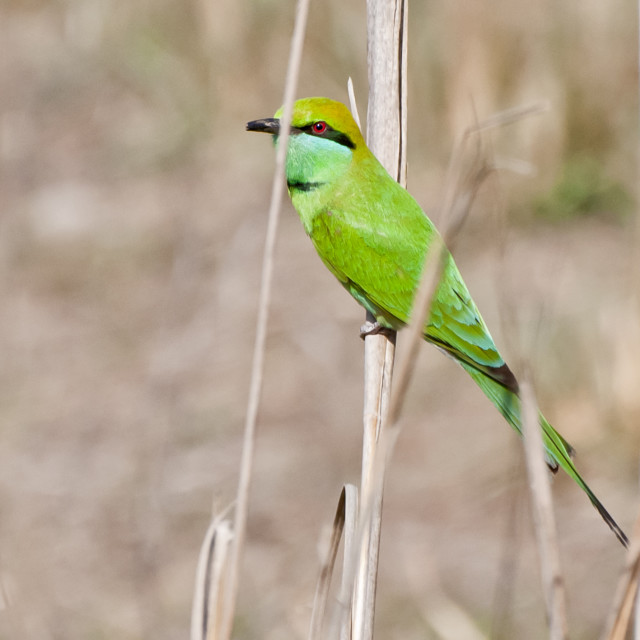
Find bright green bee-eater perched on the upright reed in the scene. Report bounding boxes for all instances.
[247,98,628,546]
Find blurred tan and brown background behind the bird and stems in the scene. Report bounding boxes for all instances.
[0,0,640,640]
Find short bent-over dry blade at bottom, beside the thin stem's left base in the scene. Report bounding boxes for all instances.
[190,518,233,640]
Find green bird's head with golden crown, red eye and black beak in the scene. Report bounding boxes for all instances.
[247,98,366,188]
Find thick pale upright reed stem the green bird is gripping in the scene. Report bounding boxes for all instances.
[352,0,408,640]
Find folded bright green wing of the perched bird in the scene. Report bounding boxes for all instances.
[311,200,517,391]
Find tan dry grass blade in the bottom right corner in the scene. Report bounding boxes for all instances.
[602,514,640,640]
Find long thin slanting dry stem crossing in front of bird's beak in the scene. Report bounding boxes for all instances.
[212,0,309,640]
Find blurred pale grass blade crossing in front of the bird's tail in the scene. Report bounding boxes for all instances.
[520,380,567,640]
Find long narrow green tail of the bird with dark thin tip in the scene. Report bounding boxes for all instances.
[460,362,629,547]
